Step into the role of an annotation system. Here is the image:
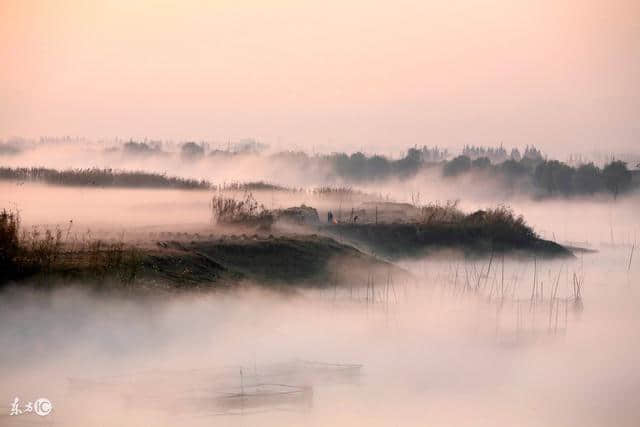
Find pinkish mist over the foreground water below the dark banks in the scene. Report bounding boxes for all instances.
[0,249,640,426]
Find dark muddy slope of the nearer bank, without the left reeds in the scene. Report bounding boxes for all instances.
[3,234,407,289]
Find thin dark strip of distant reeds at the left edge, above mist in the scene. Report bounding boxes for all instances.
[0,167,211,190]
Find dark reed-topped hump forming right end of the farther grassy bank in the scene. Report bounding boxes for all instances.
[321,205,573,260]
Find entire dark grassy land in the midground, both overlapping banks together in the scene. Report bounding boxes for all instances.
[0,196,573,289]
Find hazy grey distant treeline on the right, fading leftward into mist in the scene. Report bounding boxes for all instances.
[272,146,640,197]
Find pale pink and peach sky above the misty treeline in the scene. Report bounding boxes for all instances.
[0,0,640,155]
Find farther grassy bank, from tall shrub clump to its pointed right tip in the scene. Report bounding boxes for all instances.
[211,194,573,260]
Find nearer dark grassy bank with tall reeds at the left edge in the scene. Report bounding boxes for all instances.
[0,211,406,290]
